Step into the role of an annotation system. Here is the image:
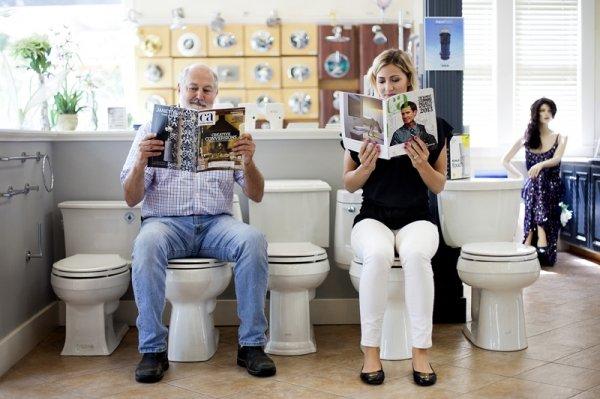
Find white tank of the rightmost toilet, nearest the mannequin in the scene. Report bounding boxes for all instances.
[437,178,523,248]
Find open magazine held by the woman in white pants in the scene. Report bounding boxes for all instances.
[340,88,437,159]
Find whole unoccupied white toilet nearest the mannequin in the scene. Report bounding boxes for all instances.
[438,178,540,351]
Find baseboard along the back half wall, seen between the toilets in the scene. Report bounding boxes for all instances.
[59,298,360,326]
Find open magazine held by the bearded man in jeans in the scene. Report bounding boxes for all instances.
[148,104,244,172]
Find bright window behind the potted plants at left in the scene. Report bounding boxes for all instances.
[0,0,135,130]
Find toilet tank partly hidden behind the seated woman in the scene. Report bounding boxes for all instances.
[333,190,362,269]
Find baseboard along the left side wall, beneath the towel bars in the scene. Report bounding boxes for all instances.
[0,302,58,376]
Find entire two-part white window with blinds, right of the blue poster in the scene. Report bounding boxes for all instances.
[463,0,594,150]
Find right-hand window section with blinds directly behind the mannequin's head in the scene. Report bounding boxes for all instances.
[513,0,581,143]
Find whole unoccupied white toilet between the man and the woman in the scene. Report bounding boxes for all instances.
[249,180,331,355]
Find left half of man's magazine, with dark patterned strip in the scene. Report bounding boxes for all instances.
[148,105,198,172]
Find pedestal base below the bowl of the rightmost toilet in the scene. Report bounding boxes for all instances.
[463,289,527,352]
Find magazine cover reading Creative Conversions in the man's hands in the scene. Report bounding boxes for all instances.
[197,108,245,172]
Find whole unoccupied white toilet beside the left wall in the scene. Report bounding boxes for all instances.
[50,201,140,356]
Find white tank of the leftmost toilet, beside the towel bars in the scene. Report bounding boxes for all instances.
[58,201,141,259]
